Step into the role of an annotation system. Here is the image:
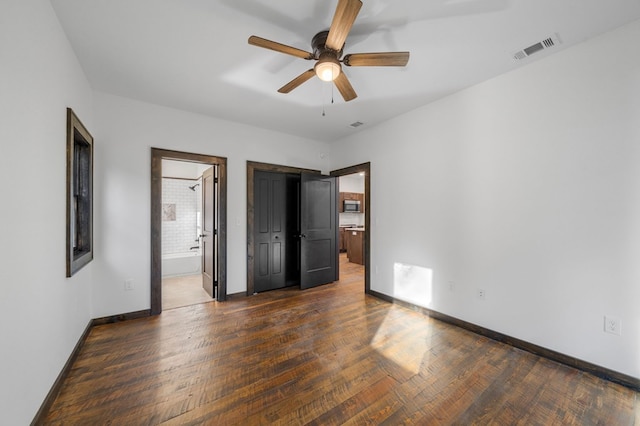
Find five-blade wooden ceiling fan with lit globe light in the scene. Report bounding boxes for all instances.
[249,0,409,102]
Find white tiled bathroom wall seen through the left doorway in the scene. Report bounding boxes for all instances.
[162,178,201,254]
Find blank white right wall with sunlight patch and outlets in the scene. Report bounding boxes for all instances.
[331,22,640,378]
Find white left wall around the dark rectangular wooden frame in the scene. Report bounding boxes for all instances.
[0,0,95,425]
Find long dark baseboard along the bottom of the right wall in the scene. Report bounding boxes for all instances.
[368,290,640,391]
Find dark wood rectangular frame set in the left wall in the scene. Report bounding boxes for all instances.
[67,108,93,277]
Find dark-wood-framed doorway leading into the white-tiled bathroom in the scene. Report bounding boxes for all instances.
[151,148,227,315]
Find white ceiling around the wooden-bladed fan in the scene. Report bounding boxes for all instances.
[51,0,640,141]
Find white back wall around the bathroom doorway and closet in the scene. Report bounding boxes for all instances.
[93,93,329,317]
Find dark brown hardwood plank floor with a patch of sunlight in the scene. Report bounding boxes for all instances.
[45,255,640,425]
